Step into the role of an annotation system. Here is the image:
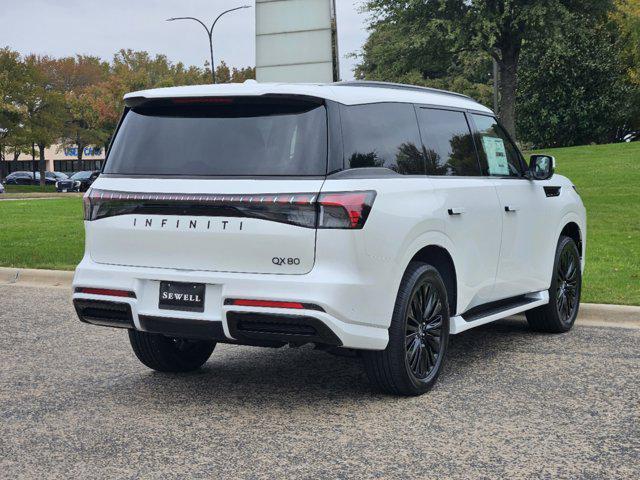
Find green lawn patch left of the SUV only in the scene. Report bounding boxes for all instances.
[0,197,84,270]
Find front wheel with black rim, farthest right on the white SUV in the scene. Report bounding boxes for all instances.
[526,236,582,333]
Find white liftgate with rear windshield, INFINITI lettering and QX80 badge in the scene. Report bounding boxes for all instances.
[86,97,327,274]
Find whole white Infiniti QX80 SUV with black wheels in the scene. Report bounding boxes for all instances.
[73,82,586,395]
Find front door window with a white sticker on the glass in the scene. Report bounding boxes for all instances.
[473,114,523,177]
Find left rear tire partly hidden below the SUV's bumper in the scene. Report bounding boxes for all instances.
[129,330,216,372]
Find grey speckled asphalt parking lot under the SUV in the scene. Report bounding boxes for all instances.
[0,286,640,478]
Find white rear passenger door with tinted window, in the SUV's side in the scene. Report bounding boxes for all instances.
[416,107,502,312]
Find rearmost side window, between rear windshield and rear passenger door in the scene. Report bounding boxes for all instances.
[340,103,424,175]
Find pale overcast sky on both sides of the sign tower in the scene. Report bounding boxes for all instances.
[0,0,366,80]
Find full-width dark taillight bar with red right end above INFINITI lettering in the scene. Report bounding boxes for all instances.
[84,189,376,229]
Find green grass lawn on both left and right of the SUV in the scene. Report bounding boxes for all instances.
[0,142,640,305]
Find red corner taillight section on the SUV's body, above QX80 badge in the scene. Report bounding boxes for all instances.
[318,191,376,229]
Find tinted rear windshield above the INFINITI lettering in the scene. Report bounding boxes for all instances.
[104,98,327,176]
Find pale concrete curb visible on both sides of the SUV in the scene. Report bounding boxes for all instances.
[0,267,640,326]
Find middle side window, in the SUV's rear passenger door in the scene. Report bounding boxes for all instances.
[417,107,482,176]
